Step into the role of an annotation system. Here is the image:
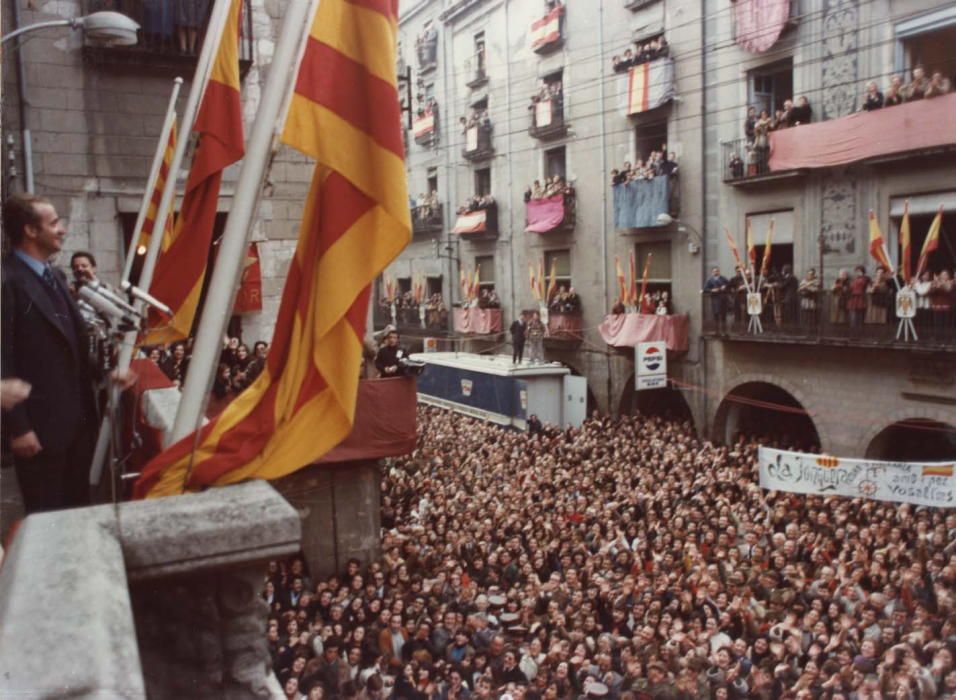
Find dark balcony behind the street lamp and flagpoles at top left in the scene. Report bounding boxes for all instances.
[83,0,254,78]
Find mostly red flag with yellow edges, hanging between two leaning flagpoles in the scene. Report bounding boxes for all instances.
[145,0,245,345]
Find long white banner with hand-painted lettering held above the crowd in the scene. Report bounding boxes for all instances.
[759,447,956,508]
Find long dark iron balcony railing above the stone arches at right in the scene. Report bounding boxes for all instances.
[701,292,956,352]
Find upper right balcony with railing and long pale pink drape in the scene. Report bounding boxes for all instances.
[722,93,956,186]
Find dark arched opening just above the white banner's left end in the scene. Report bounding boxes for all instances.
[714,382,820,452]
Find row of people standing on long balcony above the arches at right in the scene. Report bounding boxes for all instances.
[704,265,956,338]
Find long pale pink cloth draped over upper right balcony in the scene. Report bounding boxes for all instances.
[770,93,956,171]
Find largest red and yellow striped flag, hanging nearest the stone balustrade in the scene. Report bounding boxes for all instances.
[137,0,411,496]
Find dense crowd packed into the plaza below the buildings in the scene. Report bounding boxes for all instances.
[263,408,956,700]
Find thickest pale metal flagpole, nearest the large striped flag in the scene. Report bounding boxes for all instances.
[165,0,315,443]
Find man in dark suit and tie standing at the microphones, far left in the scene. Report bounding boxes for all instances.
[0,195,98,514]
